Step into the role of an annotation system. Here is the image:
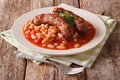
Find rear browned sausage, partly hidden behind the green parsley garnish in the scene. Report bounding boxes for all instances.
[53,7,88,34]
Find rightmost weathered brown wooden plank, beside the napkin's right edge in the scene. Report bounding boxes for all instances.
[80,0,120,80]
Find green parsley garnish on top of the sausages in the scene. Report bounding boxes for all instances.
[59,11,75,26]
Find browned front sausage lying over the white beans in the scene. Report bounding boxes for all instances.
[32,14,75,39]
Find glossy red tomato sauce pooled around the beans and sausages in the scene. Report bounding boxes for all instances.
[23,22,96,50]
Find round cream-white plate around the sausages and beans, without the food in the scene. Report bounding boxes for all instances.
[12,7,106,56]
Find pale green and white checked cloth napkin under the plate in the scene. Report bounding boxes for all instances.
[0,4,116,68]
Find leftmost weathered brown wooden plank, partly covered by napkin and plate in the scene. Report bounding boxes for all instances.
[0,0,29,80]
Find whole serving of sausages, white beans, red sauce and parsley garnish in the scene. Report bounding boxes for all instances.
[23,7,96,50]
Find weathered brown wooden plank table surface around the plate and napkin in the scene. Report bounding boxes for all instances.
[0,0,120,80]
